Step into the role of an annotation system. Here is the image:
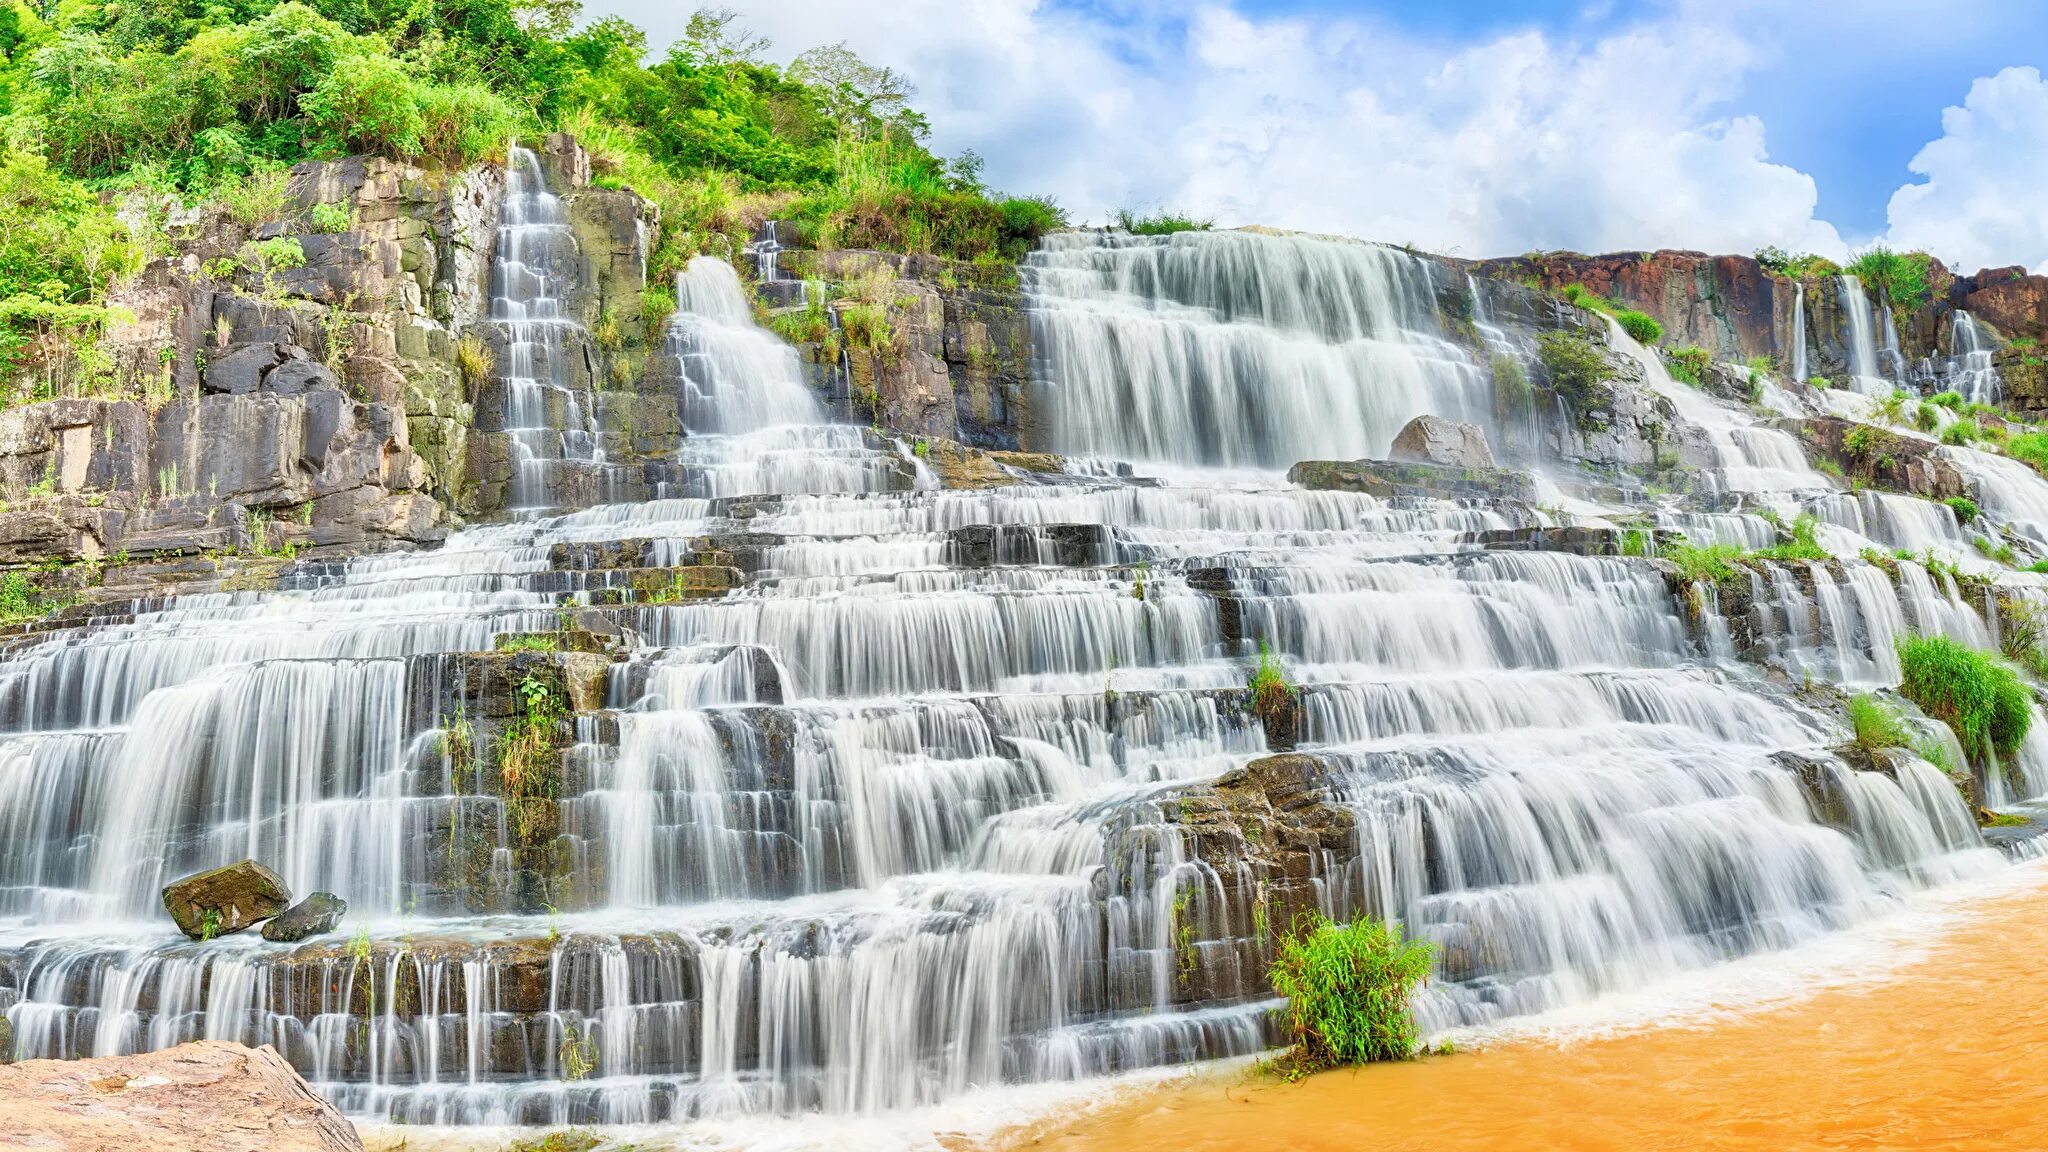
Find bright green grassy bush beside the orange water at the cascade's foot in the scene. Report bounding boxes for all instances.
[1268,916,1436,1076]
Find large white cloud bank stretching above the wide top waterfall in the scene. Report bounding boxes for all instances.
[592,0,1843,256]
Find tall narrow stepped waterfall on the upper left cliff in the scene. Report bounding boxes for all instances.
[489,146,604,508]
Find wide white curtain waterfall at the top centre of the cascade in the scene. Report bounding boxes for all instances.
[1024,232,1493,469]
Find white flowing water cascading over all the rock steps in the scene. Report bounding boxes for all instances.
[0,219,2048,1123]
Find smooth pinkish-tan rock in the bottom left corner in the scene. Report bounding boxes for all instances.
[0,1039,362,1152]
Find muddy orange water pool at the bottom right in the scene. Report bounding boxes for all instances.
[1004,869,2048,1152]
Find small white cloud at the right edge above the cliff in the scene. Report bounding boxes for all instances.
[1886,68,2048,271]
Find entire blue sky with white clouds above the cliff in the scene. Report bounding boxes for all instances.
[586,0,2048,271]
